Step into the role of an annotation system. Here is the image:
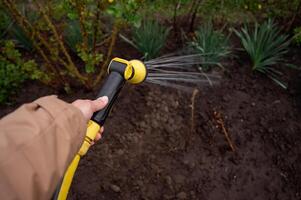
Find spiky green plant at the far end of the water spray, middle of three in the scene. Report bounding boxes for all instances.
[189,23,231,71]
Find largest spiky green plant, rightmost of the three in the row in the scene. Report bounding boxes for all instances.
[234,19,291,89]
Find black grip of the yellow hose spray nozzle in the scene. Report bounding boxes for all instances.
[91,71,125,126]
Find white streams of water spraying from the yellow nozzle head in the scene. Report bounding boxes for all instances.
[144,54,220,91]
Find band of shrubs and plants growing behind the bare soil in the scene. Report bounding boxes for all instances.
[0,0,301,103]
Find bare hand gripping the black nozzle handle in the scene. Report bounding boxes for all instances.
[72,96,108,144]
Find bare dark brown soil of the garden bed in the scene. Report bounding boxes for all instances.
[0,43,301,200]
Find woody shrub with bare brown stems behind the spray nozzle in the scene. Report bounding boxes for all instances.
[0,0,140,90]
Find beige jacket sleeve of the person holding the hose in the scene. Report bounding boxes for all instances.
[0,96,86,200]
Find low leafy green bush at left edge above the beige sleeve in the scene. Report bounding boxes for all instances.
[0,40,48,104]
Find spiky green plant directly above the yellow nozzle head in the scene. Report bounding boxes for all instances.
[133,20,170,60]
